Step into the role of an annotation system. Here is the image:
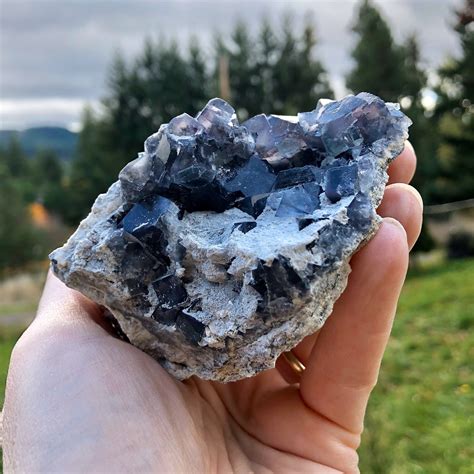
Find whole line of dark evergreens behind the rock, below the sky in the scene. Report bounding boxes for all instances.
[0,0,474,270]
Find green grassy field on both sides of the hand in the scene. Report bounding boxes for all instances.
[0,260,474,474]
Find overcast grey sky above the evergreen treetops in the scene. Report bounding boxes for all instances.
[0,0,462,129]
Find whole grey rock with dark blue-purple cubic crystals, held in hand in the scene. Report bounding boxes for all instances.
[51,93,410,381]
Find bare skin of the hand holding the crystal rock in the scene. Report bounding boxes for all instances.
[0,144,422,473]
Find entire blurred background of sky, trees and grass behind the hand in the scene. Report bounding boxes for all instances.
[0,0,474,473]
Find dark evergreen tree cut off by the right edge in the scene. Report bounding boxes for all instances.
[436,0,474,202]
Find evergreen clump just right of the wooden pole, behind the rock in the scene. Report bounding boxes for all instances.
[214,16,334,119]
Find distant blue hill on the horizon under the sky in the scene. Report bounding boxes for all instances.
[0,127,77,160]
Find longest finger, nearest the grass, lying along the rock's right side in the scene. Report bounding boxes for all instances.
[300,218,408,433]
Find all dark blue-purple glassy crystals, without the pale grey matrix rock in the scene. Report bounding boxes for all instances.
[113,94,410,330]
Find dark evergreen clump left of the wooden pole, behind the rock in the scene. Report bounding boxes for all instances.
[102,39,209,168]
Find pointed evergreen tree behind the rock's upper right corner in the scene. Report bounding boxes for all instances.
[347,0,439,202]
